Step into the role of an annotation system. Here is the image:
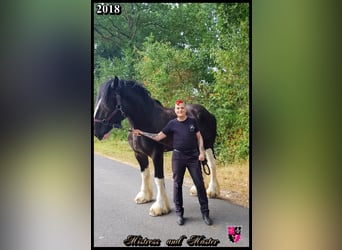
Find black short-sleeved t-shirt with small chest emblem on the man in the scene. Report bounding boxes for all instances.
[162,117,199,151]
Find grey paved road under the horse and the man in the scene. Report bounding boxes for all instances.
[93,154,249,247]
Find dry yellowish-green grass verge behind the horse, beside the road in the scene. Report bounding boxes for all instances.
[94,134,249,207]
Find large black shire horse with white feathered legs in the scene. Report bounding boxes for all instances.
[94,76,219,216]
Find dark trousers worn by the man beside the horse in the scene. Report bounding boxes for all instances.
[172,151,209,216]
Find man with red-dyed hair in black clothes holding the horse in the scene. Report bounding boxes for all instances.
[133,100,212,225]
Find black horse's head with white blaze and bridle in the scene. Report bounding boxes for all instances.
[94,77,125,140]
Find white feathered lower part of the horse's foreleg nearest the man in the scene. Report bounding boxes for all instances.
[150,178,171,216]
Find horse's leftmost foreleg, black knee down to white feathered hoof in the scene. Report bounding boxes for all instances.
[134,152,153,203]
